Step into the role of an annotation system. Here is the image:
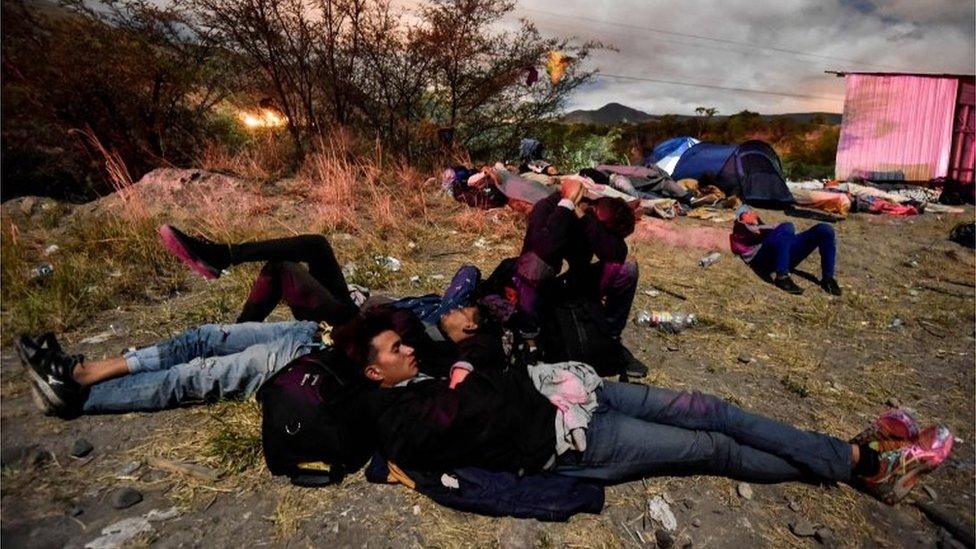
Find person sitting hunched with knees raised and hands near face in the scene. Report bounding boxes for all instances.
[512,179,647,362]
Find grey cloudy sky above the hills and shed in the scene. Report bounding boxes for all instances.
[500,0,976,114]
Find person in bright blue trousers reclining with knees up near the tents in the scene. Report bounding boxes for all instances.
[729,205,841,295]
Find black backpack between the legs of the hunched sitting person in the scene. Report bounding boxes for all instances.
[539,299,627,376]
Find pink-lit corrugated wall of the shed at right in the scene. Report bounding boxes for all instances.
[835,74,959,181]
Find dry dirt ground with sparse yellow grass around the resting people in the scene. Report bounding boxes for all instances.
[0,185,976,547]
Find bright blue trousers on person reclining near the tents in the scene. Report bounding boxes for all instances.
[750,223,837,278]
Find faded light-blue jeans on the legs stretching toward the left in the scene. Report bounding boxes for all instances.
[82,321,318,413]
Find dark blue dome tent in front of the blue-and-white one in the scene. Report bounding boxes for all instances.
[671,140,794,208]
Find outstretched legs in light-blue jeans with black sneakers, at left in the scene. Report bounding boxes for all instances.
[17,321,321,417]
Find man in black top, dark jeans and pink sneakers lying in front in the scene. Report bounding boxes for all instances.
[335,306,953,503]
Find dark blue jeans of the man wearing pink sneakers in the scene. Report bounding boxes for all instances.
[555,381,853,483]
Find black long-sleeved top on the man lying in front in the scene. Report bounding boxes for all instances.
[369,368,556,472]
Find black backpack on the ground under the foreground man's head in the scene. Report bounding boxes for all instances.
[257,349,374,486]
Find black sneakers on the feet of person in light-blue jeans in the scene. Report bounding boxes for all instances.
[15,334,84,416]
